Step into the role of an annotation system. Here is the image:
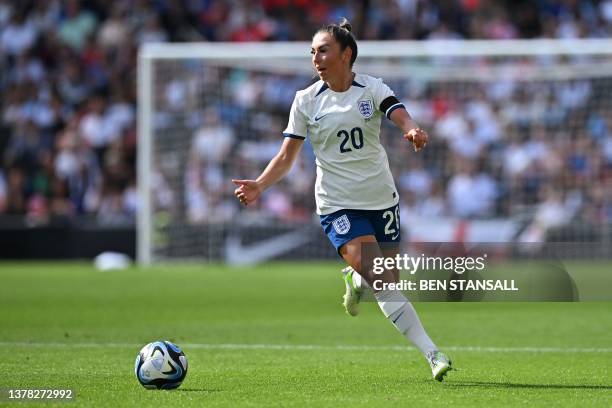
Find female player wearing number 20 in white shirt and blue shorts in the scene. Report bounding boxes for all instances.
[232,19,451,381]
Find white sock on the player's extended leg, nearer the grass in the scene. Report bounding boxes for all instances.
[374,290,438,356]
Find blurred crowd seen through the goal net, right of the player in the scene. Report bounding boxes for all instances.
[394,78,612,234]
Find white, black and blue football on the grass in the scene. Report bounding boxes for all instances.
[134,341,187,390]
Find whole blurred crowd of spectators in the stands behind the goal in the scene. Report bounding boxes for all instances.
[0,0,612,230]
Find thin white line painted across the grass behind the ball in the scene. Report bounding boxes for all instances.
[0,341,612,353]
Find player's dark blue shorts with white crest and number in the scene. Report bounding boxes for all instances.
[320,204,402,253]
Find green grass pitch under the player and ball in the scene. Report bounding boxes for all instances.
[0,262,612,407]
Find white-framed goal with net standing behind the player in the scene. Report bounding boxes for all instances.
[137,40,612,264]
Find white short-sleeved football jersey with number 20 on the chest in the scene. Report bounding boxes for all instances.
[283,74,403,215]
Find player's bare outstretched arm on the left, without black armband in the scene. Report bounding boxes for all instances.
[232,137,304,205]
